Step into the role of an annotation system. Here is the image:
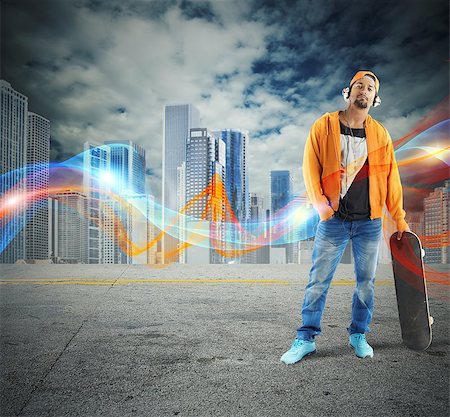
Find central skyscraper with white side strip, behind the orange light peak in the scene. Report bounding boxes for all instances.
[183,128,226,263]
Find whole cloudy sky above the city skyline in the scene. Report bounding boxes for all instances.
[1,0,449,203]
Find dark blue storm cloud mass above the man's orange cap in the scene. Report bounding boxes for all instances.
[248,0,448,115]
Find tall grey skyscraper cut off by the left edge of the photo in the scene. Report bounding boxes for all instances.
[0,80,28,263]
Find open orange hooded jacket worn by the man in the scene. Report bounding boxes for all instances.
[303,111,407,230]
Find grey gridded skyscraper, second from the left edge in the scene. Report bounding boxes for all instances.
[25,112,50,259]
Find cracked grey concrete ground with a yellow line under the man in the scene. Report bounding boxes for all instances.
[0,265,450,417]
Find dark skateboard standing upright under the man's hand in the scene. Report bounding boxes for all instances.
[390,232,433,351]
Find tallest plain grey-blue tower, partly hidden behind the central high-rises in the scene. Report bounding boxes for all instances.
[162,104,200,263]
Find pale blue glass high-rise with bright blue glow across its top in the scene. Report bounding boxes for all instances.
[83,140,156,264]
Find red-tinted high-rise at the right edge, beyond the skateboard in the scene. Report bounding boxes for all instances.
[423,180,450,264]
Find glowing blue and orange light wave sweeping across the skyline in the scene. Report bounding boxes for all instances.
[0,102,450,296]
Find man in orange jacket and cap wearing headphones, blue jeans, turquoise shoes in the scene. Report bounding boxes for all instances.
[281,71,409,364]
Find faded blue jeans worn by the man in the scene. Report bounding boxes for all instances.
[297,215,381,340]
